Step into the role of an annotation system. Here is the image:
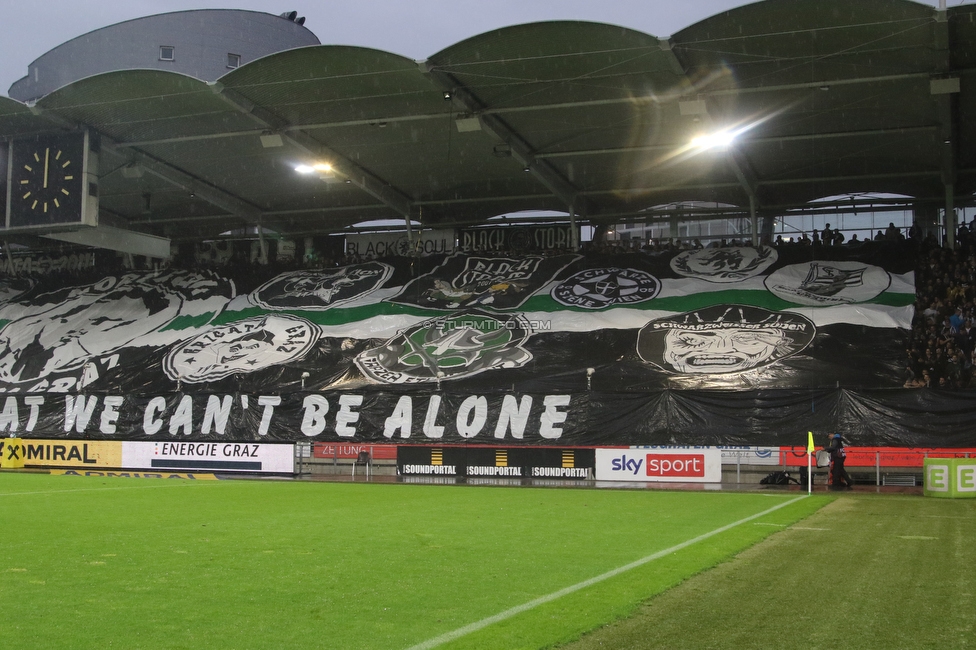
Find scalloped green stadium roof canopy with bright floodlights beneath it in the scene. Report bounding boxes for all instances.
[0,0,976,247]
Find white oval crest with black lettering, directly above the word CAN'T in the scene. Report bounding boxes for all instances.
[163,314,320,384]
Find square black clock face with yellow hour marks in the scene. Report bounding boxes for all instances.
[8,134,85,228]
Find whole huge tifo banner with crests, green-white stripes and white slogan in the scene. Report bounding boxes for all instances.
[0,243,952,446]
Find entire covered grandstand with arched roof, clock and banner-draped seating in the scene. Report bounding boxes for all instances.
[0,0,976,476]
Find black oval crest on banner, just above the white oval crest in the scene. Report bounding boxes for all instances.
[251,262,393,311]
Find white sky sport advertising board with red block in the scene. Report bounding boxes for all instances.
[596,449,722,483]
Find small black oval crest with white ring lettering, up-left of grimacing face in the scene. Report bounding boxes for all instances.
[552,268,661,309]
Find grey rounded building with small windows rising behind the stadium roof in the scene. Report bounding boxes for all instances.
[8,9,320,102]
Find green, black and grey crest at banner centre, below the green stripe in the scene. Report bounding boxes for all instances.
[356,310,532,384]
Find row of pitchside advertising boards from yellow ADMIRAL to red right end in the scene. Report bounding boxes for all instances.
[0,438,976,485]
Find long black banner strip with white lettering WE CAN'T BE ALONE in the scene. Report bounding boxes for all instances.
[7,389,976,447]
